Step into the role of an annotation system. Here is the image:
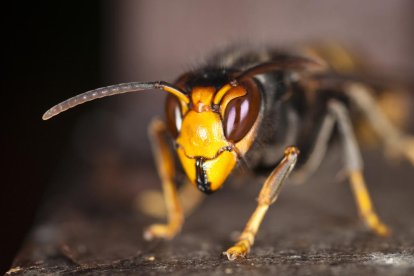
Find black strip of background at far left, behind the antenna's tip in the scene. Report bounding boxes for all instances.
[0,1,104,271]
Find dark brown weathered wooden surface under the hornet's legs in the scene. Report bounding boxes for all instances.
[8,153,414,275]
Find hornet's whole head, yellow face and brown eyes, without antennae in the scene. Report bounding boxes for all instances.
[166,73,261,194]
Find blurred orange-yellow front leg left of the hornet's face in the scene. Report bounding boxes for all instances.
[144,119,184,240]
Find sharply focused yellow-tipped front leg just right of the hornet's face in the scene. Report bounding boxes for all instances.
[223,147,299,261]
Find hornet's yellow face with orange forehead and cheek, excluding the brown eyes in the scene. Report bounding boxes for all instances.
[166,83,259,194]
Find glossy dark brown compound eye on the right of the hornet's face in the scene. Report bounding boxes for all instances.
[223,81,260,142]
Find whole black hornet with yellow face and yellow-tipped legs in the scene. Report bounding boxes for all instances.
[43,44,414,260]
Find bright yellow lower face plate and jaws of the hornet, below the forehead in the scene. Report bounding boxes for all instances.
[176,110,237,192]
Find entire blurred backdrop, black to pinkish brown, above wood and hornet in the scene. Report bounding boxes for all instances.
[0,0,414,270]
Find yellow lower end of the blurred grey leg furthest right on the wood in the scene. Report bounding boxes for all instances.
[350,171,391,236]
